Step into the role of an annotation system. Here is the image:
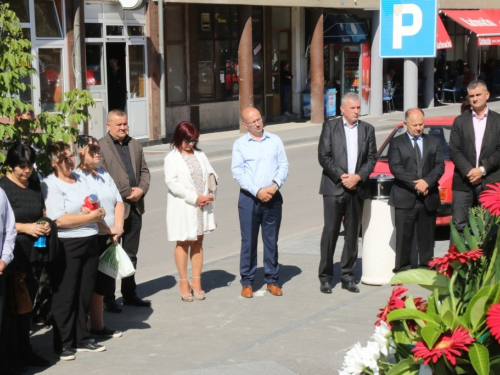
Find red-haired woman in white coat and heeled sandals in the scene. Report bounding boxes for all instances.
[164,122,217,302]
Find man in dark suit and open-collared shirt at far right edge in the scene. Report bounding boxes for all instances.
[450,80,500,236]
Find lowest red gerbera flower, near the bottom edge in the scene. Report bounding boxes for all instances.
[411,327,474,365]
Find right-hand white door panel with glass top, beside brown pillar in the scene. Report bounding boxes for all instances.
[127,43,149,138]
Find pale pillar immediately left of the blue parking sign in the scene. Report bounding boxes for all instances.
[370,10,384,115]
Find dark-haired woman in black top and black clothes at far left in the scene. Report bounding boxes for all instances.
[0,144,51,370]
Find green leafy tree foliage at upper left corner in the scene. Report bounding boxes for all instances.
[0,3,95,176]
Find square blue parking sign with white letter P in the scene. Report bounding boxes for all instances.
[380,0,437,57]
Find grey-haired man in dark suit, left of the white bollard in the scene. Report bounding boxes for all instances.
[318,92,377,293]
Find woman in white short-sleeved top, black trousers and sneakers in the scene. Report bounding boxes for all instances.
[41,142,106,361]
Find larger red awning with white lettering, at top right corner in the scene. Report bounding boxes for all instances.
[443,9,500,37]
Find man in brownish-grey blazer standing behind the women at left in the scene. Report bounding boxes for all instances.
[99,110,151,312]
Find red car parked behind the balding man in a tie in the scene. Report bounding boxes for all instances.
[370,116,456,226]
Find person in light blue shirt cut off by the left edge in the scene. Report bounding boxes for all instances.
[0,189,17,374]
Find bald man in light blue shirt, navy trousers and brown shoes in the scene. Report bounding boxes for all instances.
[231,107,288,298]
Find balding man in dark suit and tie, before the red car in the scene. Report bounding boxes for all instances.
[388,108,444,272]
